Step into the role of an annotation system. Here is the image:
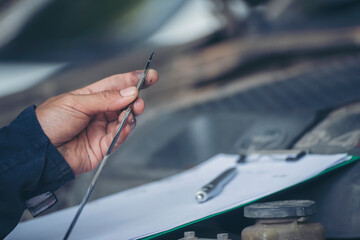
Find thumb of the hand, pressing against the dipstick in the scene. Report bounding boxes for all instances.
[73,87,138,115]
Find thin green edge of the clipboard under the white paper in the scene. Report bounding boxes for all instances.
[140,155,360,240]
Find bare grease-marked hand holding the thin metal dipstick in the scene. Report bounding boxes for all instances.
[35,70,158,175]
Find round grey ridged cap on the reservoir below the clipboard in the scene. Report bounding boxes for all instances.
[244,200,316,218]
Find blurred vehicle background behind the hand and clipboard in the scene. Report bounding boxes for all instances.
[0,0,360,237]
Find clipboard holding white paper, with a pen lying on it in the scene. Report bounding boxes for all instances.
[5,154,359,239]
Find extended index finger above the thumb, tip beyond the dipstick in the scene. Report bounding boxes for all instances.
[74,69,159,94]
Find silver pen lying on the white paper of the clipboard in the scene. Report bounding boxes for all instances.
[195,167,237,203]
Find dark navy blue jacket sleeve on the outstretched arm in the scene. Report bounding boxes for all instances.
[0,106,74,239]
